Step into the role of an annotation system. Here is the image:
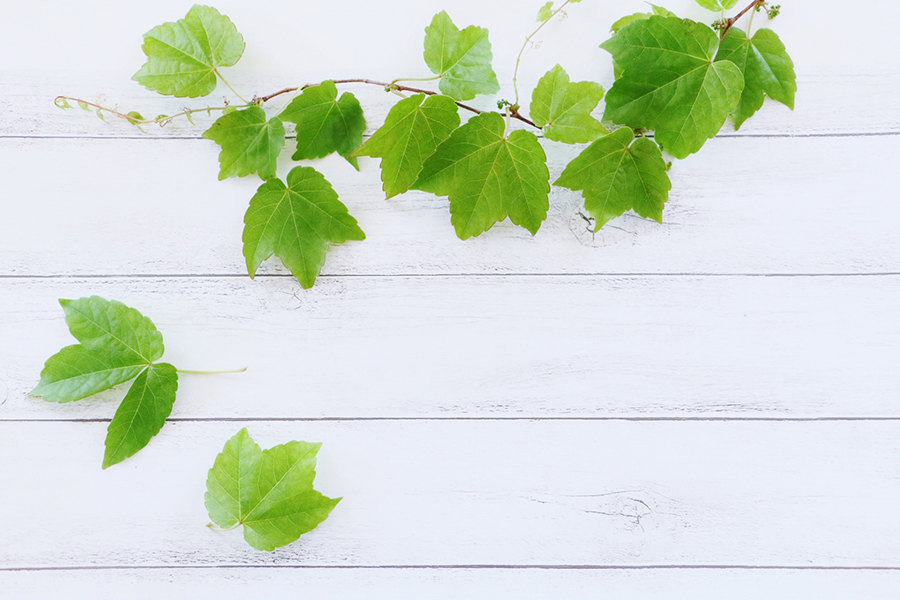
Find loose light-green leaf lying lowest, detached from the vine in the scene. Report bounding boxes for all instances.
[205,429,341,551]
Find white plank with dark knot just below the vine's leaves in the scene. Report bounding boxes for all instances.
[0,136,900,275]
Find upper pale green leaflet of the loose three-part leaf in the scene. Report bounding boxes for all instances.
[59,296,165,364]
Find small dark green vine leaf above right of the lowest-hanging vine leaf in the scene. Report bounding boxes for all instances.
[278,81,366,171]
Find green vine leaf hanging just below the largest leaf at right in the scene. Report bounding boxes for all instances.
[554,127,672,231]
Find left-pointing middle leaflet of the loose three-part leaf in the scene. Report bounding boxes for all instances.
[31,344,147,402]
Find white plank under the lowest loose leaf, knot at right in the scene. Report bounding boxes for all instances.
[0,421,900,568]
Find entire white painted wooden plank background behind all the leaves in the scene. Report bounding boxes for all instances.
[0,0,900,600]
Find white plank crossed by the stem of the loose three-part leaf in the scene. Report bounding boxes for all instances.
[0,277,900,419]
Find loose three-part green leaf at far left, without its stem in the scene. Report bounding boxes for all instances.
[31,296,178,469]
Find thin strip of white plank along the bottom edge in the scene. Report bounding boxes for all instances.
[0,568,900,600]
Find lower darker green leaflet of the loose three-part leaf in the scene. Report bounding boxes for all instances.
[103,363,178,469]
